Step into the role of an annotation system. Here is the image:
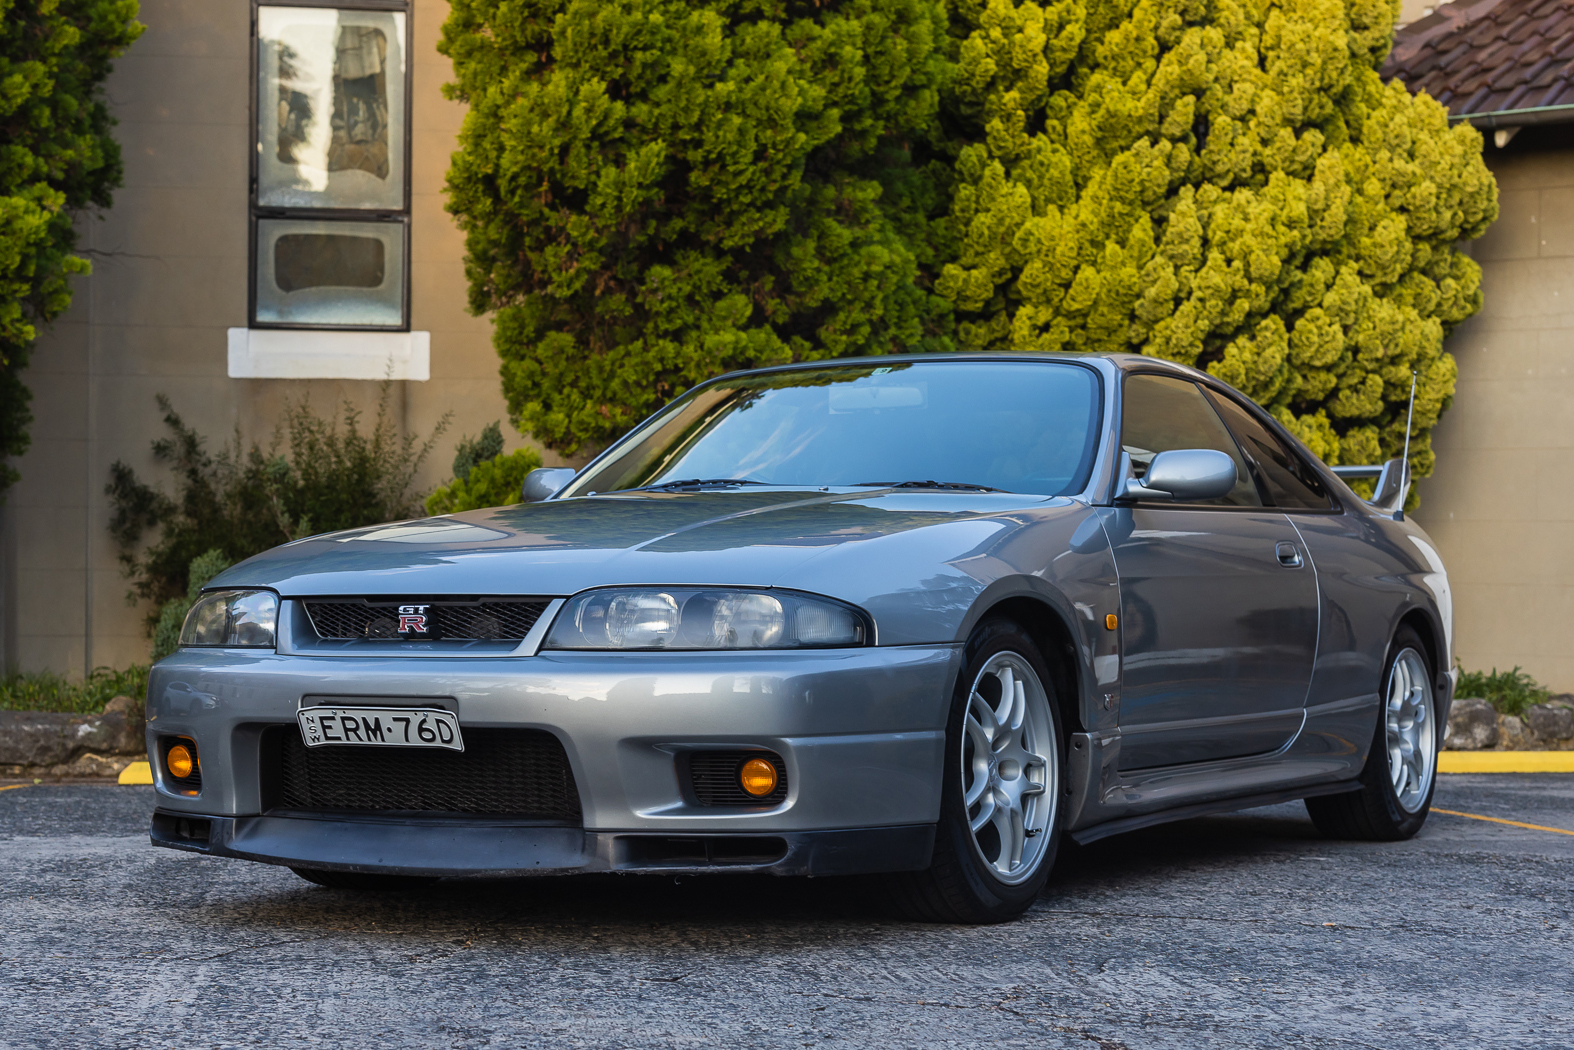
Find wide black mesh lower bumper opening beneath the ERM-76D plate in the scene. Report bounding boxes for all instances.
[263,726,581,823]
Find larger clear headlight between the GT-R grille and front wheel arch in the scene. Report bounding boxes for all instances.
[546,587,869,649]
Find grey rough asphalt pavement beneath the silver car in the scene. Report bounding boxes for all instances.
[0,775,1574,1050]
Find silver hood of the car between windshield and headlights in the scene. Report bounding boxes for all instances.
[209,488,1086,641]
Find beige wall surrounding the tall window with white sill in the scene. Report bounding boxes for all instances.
[0,0,556,674]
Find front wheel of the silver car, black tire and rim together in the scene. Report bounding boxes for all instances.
[886,620,1066,924]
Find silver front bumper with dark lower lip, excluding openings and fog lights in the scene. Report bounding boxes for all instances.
[148,645,960,874]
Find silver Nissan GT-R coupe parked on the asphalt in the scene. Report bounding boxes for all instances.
[148,354,1453,922]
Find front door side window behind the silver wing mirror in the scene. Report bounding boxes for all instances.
[1121,375,1262,507]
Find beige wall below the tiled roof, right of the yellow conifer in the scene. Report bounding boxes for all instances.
[1417,143,1574,691]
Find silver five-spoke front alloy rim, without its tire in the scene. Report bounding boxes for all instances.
[962,652,1059,885]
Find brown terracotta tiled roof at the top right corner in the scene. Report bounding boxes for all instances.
[1382,0,1574,123]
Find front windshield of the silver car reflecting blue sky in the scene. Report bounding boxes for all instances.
[563,360,1099,496]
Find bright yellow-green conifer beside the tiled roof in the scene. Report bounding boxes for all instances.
[937,0,1497,475]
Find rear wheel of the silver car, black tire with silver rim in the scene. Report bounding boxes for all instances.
[1306,627,1443,842]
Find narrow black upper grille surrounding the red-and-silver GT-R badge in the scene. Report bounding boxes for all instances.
[301,598,548,642]
